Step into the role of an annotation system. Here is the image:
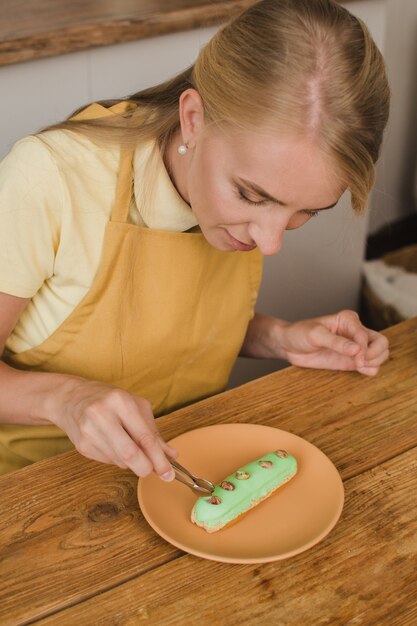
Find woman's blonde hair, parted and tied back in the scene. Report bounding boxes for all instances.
[46,0,390,212]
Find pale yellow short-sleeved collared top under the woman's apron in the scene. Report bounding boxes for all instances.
[0,130,197,353]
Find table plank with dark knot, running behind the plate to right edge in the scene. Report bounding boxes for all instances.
[0,320,417,626]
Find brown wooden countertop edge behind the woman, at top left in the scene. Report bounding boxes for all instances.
[0,0,254,65]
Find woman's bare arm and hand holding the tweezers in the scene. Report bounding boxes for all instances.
[0,292,178,480]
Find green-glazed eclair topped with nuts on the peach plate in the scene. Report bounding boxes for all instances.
[191,450,297,533]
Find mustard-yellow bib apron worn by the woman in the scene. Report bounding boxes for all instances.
[0,105,262,473]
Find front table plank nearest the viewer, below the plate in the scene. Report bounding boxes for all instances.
[32,448,417,626]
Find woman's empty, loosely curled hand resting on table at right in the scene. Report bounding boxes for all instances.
[279,311,389,376]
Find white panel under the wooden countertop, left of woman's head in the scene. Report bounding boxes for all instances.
[0,25,216,158]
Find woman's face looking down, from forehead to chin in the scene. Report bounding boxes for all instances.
[178,128,343,255]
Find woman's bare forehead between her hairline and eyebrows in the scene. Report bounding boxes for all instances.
[203,125,344,208]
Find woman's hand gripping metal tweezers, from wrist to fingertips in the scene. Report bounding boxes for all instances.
[48,378,178,481]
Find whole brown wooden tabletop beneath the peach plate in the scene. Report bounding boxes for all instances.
[0,318,417,626]
